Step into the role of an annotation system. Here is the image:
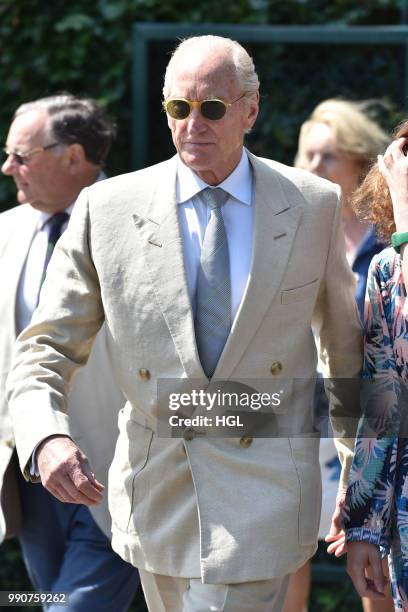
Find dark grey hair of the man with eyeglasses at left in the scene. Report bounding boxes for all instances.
[14,93,116,166]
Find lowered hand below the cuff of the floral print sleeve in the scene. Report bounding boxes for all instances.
[347,542,388,599]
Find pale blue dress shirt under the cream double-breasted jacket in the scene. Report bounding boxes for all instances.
[176,149,254,321]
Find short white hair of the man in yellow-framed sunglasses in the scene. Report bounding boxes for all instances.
[163,34,259,99]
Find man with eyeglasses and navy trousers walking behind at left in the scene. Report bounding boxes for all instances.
[0,94,138,612]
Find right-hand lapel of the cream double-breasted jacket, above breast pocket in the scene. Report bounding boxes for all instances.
[214,153,304,379]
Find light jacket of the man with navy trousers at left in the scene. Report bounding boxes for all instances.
[0,204,125,541]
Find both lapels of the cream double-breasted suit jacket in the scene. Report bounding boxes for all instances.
[133,154,304,379]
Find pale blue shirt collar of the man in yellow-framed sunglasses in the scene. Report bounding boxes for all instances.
[176,148,252,206]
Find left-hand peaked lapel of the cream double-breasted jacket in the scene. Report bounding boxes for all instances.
[134,157,205,379]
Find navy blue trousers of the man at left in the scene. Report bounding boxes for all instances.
[19,473,140,612]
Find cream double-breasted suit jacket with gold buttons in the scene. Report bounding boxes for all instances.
[9,155,361,583]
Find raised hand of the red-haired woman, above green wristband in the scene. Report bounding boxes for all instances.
[377,138,408,232]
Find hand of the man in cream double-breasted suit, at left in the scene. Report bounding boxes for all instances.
[36,435,104,506]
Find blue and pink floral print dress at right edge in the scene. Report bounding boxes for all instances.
[344,248,408,612]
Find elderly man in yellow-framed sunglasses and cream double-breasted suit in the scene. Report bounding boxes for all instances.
[8,36,361,612]
